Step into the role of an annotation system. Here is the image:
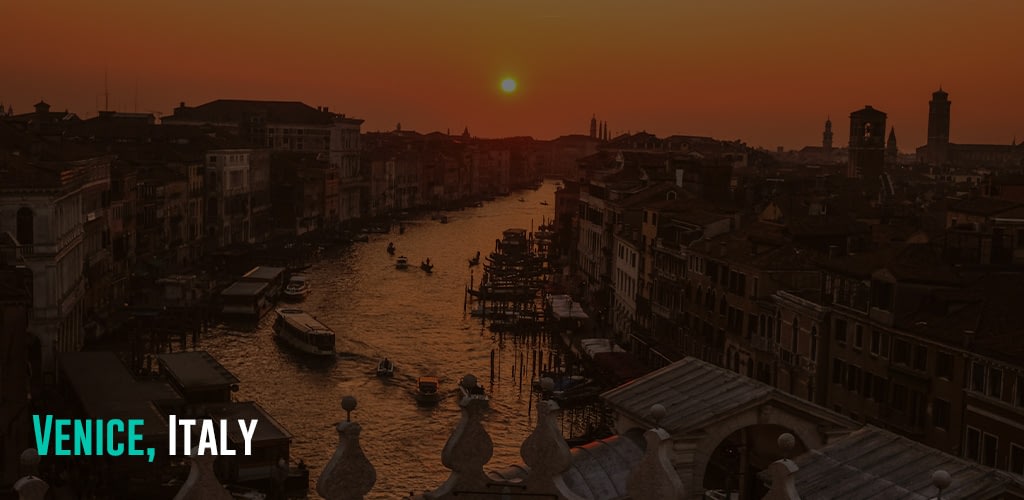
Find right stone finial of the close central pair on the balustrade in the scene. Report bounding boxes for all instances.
[519,400,580,500]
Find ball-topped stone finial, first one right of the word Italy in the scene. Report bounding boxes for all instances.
[316,395,377,500]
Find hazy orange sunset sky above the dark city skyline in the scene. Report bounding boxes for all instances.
[0,0,1024,151]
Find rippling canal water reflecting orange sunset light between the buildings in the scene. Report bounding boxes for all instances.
[200,181,556,498]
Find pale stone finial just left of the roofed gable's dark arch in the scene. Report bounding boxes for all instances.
[626,426,684,500]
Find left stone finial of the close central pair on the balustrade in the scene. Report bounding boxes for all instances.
[426,375,495,498]
